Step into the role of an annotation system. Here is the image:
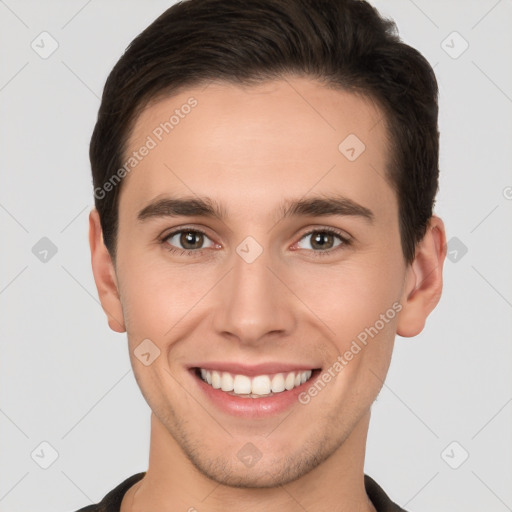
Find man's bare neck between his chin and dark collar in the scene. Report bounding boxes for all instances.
[121,412,375,512]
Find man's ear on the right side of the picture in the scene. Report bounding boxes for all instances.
[397,215,446,337]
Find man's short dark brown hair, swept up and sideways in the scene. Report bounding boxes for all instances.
[90,0,439,263]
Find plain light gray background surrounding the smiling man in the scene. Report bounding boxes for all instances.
[0,0,512,512]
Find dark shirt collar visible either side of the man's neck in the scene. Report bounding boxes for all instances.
[76,472,407,512]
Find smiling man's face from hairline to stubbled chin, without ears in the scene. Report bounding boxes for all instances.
[95,78,432,487]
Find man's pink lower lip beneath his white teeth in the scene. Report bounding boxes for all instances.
[190,369,320,418]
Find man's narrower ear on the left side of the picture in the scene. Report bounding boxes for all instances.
[89,208,126,332]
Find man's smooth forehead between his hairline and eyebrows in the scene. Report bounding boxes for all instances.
[121,78,394,224]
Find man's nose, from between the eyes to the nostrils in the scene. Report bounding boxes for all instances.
[213,246,297,345]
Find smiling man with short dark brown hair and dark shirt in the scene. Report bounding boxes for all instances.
[82,0,446,512]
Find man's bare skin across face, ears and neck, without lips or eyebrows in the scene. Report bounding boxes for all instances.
[89,77,446,512]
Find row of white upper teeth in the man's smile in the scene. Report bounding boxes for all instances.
[201,368,312,395]
